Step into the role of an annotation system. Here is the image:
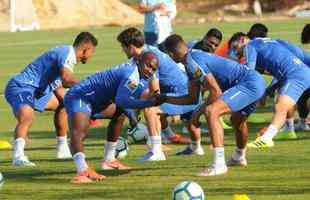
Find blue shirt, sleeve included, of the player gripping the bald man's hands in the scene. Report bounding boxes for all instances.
[186,49,250,91]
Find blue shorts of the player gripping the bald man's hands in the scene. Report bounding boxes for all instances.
[220,71,266,116]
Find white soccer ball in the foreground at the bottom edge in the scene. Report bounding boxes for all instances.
[172,181,205,200]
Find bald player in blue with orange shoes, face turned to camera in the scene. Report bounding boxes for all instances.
[64,52,162,183]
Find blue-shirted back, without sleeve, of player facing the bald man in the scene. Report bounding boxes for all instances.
[190,50,250,90]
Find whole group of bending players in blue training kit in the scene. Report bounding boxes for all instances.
[5,24,310,183]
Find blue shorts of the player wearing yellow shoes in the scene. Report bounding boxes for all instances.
[279,68,310,103]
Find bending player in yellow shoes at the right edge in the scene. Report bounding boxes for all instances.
[228,37,310,148]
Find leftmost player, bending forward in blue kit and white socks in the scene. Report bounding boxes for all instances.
[5,32,98,166]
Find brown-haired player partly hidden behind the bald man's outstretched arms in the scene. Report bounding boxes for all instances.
[117,28,197,161]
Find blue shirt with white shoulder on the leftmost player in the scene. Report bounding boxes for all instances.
[13,46,76,90]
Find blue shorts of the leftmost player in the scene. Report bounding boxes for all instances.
[5,80,54,114]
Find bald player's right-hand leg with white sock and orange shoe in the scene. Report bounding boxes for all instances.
[101,104,130,170]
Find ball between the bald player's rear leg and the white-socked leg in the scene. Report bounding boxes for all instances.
[127,123,148,144]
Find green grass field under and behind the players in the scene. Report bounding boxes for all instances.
[0,20,310,200]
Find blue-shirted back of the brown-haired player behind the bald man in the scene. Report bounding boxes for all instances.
[146,46,188,93]
